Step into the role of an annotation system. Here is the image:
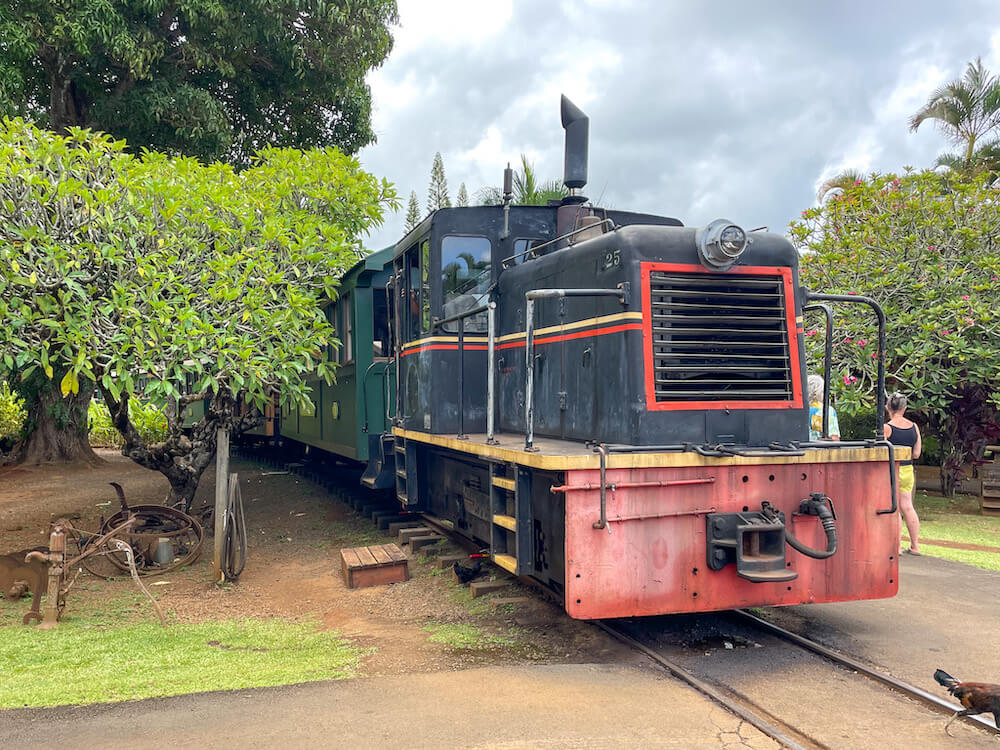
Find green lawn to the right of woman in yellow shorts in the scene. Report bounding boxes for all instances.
[903,491,1000,570]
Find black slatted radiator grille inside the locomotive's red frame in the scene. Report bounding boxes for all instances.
[649,271,793,403]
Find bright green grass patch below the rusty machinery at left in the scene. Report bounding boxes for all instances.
[0,596,368,709]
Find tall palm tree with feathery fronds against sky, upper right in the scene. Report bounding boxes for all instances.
[910,57,1000,169]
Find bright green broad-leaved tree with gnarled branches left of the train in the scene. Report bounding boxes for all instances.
[0,121,395,506]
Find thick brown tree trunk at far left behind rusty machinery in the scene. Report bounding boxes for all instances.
[11,372,104,466]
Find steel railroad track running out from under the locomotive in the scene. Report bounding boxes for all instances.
[238,452,1000,750]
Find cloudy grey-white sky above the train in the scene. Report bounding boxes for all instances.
[361,0,1000,253]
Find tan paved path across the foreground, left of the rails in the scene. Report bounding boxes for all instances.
[0,665,776,750]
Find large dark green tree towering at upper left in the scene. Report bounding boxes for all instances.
[0,0,397,165]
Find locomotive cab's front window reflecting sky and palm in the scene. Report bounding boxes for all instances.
[441,236,491,333]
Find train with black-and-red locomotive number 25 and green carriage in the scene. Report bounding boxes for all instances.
[278,97,905,619]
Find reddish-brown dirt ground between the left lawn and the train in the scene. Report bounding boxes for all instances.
[0,451,642,676]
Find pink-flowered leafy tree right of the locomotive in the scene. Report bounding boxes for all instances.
[790,171,1000,494]
